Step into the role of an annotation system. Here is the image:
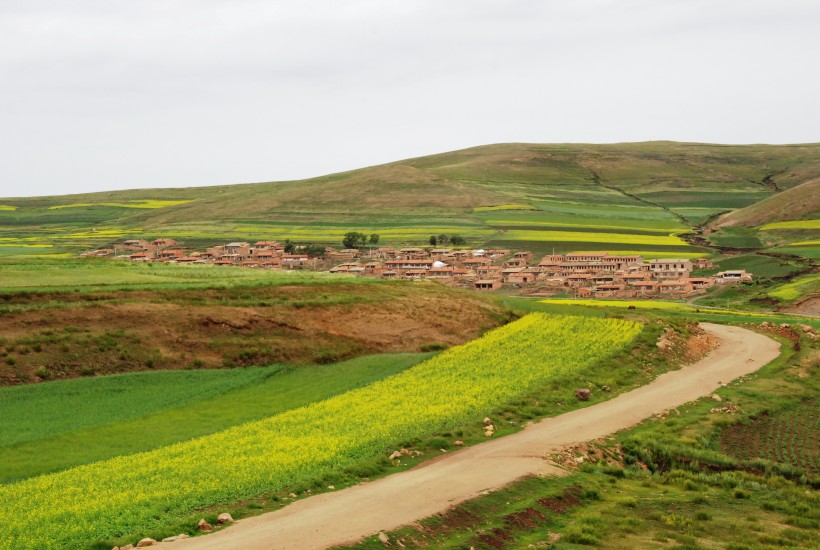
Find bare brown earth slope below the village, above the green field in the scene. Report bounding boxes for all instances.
[0,284,506,385]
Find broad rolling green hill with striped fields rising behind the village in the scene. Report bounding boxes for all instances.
[0,142,820,256]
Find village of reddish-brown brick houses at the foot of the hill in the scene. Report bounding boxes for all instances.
[83,239,752,298]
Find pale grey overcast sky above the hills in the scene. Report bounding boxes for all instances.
[0,0,820,197]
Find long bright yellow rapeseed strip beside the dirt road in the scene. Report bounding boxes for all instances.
[0,313,641,548]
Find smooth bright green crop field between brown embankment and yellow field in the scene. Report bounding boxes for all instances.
[0,353,434,483]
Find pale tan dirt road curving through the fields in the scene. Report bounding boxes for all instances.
[171,323,780,550]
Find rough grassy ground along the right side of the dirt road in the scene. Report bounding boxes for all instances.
[345,332,820,550]
